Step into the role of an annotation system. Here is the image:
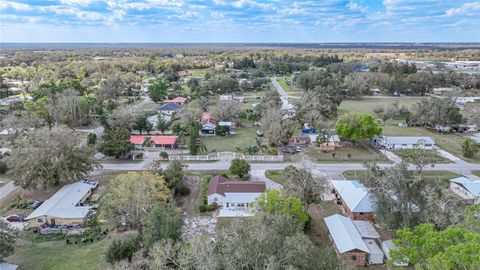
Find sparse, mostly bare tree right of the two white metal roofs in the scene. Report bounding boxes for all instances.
[362,163,464,229]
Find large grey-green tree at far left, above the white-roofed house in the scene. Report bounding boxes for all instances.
[7,127,97,189]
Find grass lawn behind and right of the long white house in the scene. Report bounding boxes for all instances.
[382,126,480,163]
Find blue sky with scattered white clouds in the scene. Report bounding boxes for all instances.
[0,0,480,42]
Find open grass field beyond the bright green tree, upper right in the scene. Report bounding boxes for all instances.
[339,97,421,115]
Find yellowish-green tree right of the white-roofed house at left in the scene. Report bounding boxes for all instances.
[100,172,172,231]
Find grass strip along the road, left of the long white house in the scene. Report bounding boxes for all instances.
[305,146,389,162]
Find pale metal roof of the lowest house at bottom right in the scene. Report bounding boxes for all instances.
[323,214,370,253]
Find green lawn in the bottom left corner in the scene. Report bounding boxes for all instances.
[7,236,109,270]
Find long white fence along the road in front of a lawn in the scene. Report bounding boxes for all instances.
[168,152,283,162]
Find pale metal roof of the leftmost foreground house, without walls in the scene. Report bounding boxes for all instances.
[26,182,93,220]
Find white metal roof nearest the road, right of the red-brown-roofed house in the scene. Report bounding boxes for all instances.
[330,180,373,213]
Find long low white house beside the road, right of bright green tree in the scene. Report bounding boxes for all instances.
[372,136,435,150]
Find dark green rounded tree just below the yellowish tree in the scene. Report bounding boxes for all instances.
[143,202,183,247]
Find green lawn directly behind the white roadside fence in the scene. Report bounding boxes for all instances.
[201,127,257,153]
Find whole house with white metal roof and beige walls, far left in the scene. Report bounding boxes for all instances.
[26,181,95,227]
